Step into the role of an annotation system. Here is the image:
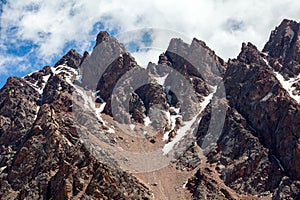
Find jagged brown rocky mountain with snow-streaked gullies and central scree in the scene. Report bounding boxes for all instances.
[0,19,300,200]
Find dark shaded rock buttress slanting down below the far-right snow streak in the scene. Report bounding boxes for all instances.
[224,41,300,178]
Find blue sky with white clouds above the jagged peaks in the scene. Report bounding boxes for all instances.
[0,0,300,88]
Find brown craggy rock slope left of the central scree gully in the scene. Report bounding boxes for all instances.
[0,51,150,199]
